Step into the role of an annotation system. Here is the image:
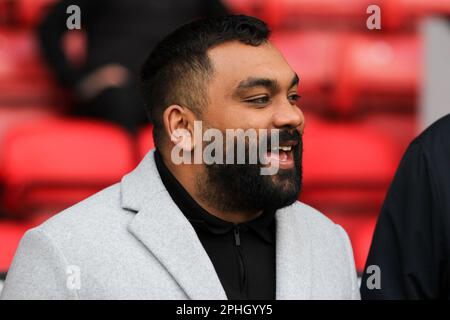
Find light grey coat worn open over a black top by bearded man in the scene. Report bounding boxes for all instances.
[1,151,359,299]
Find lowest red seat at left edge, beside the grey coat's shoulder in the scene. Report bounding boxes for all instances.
[0,220,33,273]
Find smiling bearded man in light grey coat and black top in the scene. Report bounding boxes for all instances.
[3,16,359,299]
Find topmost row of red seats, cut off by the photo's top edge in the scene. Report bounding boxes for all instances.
[0,0,450,30]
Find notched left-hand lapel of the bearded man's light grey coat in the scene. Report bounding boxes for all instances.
[121,151,227,300]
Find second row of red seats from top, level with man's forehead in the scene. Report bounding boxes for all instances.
[0,30,422,115]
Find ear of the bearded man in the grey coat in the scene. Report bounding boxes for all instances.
[163,105,195,152]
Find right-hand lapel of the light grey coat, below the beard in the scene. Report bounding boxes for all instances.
[275,206,313,300]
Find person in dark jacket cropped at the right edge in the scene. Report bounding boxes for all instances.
[361,115,450,299]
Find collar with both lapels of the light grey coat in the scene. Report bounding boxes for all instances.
[121,150,312,300]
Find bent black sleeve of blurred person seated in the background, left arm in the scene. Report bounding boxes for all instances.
[37,0,90,86]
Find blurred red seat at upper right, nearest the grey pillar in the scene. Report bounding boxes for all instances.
[331,35,422,114]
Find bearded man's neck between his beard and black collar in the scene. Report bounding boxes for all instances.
[161,154,263,224]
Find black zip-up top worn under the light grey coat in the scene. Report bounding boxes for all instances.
[155,151,276,300]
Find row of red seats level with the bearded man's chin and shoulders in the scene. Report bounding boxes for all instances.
[0,116,412,269]
